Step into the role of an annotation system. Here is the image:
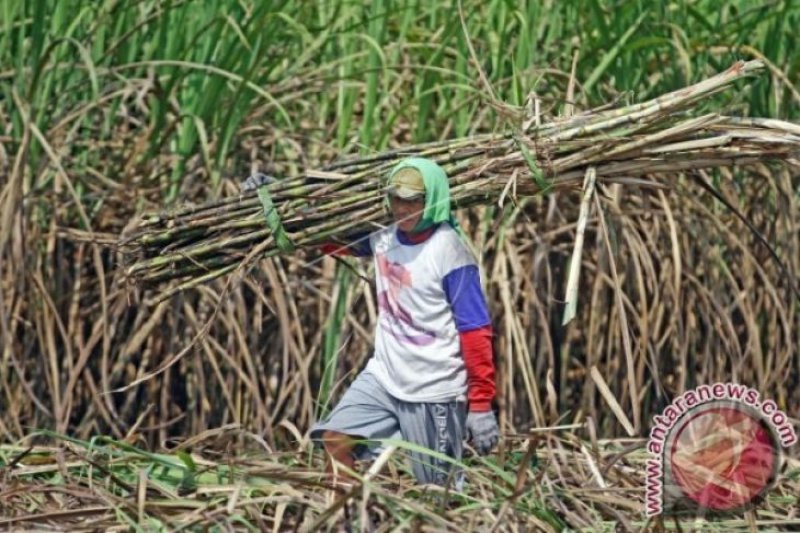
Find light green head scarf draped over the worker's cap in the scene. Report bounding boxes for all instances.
[389,157,463,236]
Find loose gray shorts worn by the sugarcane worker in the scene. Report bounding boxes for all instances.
[311,371,467,488]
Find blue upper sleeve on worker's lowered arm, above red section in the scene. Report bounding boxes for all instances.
[442,265,491,332]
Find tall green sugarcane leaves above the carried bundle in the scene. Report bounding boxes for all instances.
[0,0,800,199]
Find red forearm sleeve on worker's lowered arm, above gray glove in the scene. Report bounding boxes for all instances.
[459,325,495,412]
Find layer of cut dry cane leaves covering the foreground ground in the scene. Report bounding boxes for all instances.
[0,434,800,532]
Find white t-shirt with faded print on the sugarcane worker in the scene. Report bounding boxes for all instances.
[365,224,488,402]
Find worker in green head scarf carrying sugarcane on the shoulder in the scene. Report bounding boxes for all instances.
[311,158,498,486]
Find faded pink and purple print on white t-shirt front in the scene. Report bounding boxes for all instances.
[376,254,436,346]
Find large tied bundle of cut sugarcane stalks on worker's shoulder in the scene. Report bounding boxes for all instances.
[121,61,800,297]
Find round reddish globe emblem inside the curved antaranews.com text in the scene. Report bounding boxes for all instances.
[665,401,780,511]
